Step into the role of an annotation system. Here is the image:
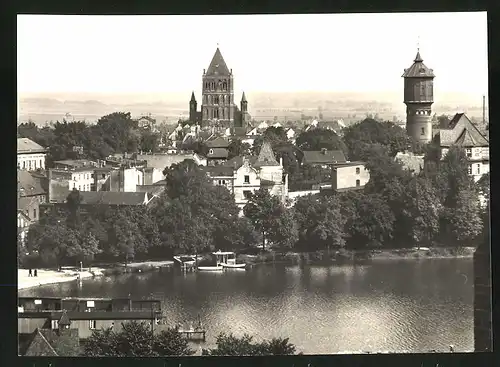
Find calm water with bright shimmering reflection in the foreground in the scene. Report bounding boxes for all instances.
[19,259,474,354]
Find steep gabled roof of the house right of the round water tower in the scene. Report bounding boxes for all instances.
[439,113,489,147]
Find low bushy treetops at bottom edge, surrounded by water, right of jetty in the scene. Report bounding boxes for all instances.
[203,333,296,356]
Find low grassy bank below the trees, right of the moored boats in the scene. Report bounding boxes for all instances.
[237,247,475,266]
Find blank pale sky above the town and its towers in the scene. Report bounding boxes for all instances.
[17,12,488,98]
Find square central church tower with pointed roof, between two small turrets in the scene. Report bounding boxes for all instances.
[201,47,236,129]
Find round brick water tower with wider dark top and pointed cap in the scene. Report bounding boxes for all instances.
[402,51,435,143]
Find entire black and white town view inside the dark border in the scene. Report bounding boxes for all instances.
[16,12,492,360]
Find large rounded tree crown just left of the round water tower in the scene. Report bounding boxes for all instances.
[343,118,411,160]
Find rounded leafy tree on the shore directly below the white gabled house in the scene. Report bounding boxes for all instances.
[243,188,297,250]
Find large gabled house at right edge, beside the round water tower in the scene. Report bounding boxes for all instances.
[434,113,490,182]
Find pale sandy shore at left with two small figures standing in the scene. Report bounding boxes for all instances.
[17,260,173,290]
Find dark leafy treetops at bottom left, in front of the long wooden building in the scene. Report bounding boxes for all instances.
[82,321,194,357]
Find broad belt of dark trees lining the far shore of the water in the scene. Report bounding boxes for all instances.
[20,115,489,265]
